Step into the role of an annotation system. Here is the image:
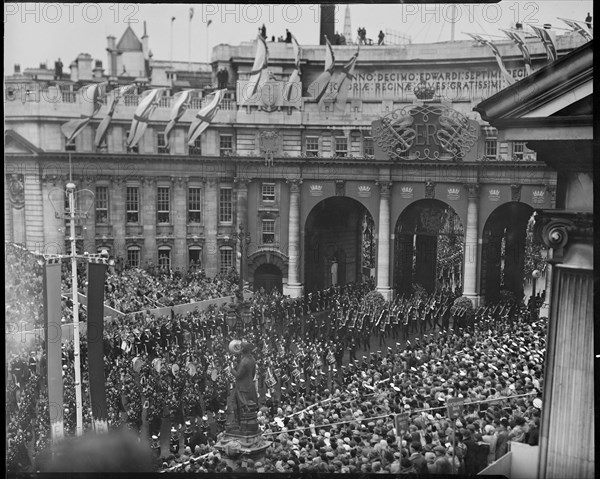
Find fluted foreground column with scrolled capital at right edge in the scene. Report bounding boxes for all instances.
[536,213,595,479]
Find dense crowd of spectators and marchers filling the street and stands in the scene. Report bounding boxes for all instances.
[6,242,546,474]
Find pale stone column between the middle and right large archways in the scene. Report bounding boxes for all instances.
[463,183,479,307]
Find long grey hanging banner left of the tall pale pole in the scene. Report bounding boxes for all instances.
[44,263,64,441]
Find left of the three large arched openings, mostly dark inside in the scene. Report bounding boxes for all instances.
[304,196,375,292]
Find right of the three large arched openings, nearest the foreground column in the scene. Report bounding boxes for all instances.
[481,201,533,301]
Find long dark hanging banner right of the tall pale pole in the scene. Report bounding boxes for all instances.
[87,263,108,433]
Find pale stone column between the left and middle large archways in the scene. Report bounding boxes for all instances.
[377,181,392,300]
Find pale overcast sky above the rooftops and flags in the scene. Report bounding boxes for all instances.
[4,0,593,74]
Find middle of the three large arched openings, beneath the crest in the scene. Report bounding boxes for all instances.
[394,199,464,294]
